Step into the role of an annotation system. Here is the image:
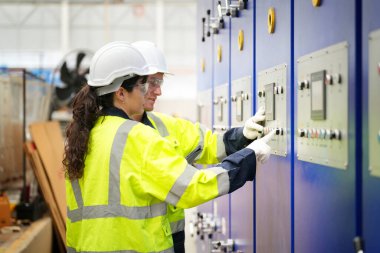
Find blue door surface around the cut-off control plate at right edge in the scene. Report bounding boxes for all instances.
[362,0,380,253]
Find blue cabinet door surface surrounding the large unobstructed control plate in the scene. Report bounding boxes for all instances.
[294,0,360,253]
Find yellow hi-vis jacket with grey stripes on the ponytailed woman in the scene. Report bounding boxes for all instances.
[66,116,256,252]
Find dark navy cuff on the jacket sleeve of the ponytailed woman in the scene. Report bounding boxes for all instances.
[220,148,256,193]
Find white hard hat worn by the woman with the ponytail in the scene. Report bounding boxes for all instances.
[87,41,155,96]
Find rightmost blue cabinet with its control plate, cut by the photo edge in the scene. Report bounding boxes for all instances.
[360,0,380,253]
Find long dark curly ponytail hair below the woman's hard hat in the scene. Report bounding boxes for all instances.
[62,76,147,180]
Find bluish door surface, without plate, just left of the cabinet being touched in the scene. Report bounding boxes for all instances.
[230,1,254,252]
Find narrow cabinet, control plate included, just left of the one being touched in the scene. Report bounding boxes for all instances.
[230,1,255,253]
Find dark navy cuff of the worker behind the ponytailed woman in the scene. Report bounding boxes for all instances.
[223,127,252,155]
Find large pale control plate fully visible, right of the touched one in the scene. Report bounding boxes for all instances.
[296,42,348,169]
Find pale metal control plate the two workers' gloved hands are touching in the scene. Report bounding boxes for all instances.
[257,64,288,157]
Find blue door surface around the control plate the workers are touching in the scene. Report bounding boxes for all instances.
[255,0,290,253]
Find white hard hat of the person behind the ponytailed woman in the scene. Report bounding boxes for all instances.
[132,40,171,74]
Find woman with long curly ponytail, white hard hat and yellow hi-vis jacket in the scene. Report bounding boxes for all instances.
[64,42,273,252]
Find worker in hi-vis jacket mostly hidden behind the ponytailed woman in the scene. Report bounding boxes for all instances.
[132,41,265,253]
